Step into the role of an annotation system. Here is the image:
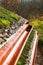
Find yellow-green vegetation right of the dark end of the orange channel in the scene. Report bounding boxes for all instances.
[29,16,43,45]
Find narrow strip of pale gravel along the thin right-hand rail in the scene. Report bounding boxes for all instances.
[24,32,36,65]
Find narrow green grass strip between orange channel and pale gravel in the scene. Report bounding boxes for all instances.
[17,31,34,65]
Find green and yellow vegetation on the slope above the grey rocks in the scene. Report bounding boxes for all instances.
[0,6,19,28]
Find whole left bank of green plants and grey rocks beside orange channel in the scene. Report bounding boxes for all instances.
[0,6,27,47]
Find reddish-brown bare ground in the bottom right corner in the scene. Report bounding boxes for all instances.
[35,45,43,65]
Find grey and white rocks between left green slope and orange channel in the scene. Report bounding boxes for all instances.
[0,17,27,47]
